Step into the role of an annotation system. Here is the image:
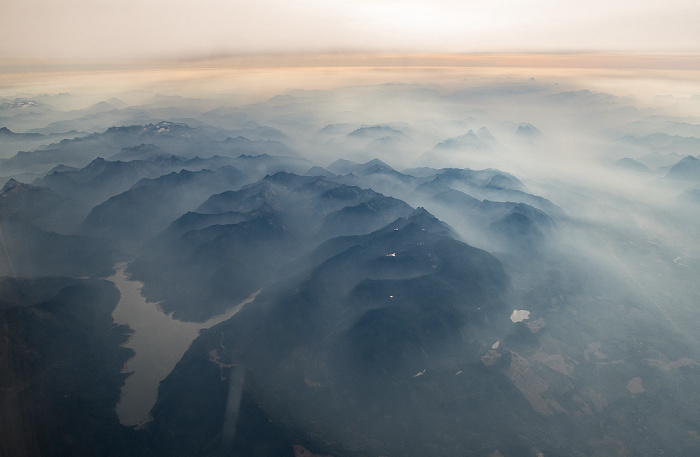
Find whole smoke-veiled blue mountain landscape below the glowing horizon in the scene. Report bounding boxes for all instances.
[0,79,700,457]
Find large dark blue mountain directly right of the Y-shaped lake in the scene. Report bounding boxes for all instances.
[144,210,509,455]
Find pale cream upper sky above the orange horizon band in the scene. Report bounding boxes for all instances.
[0,0,700,62]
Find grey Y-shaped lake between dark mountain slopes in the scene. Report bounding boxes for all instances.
[106,263,260,426]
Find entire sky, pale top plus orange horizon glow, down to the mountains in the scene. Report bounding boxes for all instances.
[0,0,700,100]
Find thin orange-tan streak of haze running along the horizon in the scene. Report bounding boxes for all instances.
[0,51,700,73]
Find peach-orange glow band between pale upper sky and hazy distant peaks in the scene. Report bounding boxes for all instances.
[0,54,700,105]
